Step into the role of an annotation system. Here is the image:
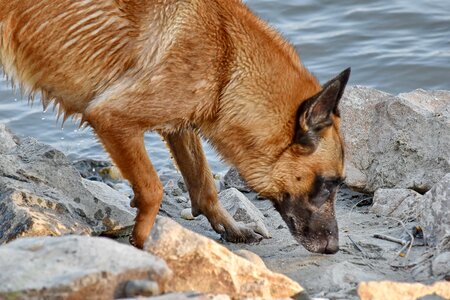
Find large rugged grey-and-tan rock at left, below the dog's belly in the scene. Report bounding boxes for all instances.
[0,129,134,244]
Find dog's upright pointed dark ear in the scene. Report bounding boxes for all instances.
[294,68,350,151]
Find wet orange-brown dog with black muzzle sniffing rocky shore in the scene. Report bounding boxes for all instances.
[0,0,350,254]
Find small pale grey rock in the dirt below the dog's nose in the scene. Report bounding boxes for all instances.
[321,261,381,291]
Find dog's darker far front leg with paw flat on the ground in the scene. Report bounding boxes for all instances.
[162,130,262,243]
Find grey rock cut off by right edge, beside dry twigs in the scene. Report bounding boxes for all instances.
[417,173,450,247]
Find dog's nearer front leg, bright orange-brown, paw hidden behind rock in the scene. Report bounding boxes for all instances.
[87,109,163,248]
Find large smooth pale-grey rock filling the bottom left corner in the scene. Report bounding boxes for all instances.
[0,236,172,299]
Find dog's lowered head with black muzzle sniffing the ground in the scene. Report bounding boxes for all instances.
[270,69,350,254]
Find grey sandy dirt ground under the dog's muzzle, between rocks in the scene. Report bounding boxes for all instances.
[154,184,430,299]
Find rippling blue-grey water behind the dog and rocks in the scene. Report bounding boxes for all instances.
[0,0,450,172]
